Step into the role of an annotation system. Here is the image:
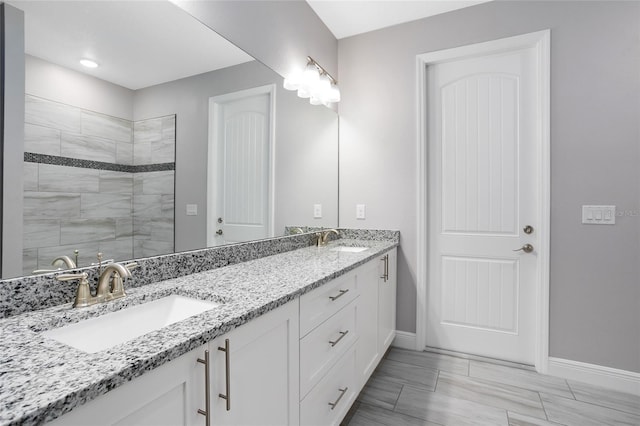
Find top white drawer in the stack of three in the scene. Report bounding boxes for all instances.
[300,272,358,337]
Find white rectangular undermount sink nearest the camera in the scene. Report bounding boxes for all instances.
[43,294,220,353]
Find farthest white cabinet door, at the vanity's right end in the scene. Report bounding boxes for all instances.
[378,249,397,355]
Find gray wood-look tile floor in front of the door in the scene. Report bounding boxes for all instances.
[342,348,640,426]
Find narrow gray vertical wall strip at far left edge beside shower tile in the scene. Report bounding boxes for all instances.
[0,4,24,276]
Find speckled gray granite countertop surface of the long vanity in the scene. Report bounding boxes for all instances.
[0,239,398,425]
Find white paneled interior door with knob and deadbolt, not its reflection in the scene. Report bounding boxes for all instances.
[426,48,539,364]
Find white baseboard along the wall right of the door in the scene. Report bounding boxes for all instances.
[547,357,640,395]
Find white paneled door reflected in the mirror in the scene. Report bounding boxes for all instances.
[207,87,273,246]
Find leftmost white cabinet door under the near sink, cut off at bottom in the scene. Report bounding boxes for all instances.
[51,345,207,426]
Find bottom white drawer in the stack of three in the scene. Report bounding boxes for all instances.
[300,346,358,426]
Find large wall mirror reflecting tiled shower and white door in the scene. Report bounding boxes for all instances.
[2,0,338,278]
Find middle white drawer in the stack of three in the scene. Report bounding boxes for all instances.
[300,300,358,397]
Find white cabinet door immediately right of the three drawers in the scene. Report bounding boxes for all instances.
[356,260,380,386]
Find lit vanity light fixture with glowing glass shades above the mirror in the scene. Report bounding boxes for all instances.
[283,56,340,106]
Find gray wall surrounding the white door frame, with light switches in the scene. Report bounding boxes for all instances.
[339,1,640,372]
